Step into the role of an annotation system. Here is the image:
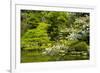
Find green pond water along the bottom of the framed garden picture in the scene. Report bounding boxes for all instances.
[21,51,89,63]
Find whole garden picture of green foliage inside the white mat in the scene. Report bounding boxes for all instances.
[21,10,90,62]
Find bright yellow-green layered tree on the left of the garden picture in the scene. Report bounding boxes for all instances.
[21,23,49,50]
